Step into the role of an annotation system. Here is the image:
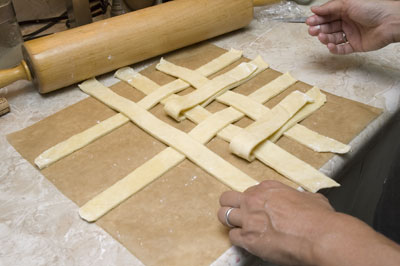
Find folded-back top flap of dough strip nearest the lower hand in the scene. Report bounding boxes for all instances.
[229,91,313,161]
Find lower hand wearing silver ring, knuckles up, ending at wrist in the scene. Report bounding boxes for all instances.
[218,181,335,265]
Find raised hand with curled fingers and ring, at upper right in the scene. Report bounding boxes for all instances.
[306,0,400,54]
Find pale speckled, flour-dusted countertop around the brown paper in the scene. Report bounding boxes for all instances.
[0,2,400,265]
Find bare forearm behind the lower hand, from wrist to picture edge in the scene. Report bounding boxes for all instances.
[314,213,400,266]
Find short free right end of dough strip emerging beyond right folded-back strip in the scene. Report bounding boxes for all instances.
[284,124,350,154]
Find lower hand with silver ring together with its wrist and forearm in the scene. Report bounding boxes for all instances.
[218,181,400,266]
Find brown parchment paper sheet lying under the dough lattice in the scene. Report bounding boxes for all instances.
[7,44,381,265]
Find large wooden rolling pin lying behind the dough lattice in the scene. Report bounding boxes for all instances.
[0,0,276,93]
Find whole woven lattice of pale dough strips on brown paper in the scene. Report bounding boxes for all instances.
[35,49,348,224]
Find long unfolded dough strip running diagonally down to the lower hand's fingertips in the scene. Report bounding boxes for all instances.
[79,79,258,191]
